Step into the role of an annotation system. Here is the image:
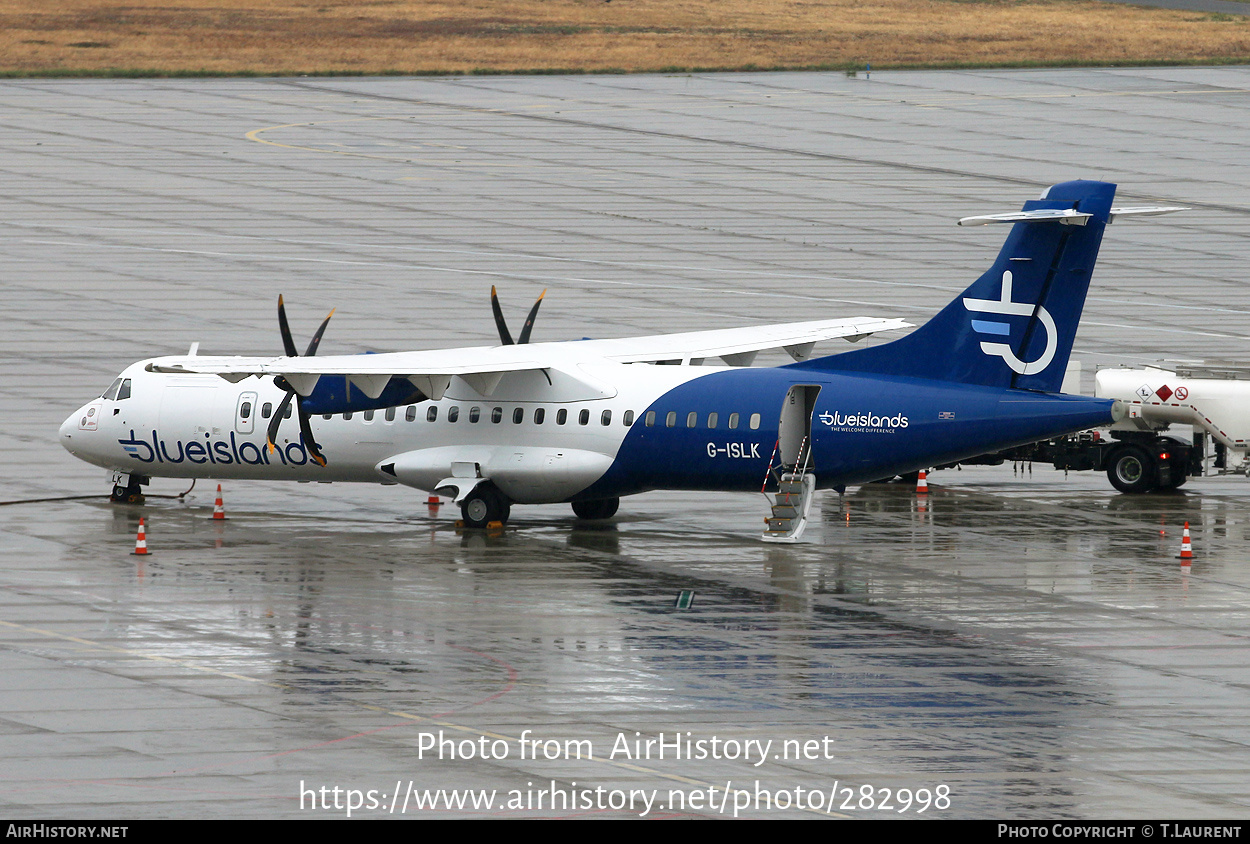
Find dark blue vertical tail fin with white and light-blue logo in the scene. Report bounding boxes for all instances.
[795,181,1115,393]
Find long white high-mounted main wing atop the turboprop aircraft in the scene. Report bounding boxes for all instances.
[148,318,910,399]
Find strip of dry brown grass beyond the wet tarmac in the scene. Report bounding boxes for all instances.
[0,0,1250,74]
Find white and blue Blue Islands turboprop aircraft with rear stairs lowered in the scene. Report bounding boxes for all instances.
[60,181,1179,541]
